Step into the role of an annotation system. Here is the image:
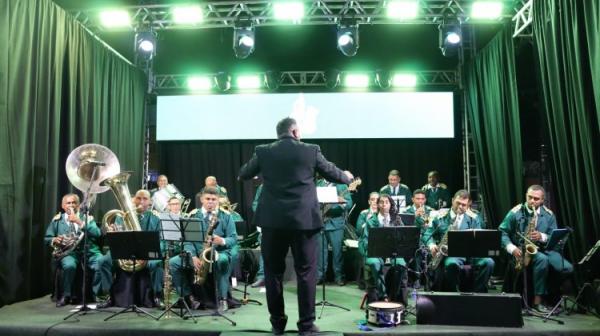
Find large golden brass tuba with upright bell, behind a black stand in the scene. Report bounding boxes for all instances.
[101,172,147,272]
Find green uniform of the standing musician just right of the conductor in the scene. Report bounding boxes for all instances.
[317,179,352,283]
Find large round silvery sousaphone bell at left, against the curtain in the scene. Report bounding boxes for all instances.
[65,144,121,194]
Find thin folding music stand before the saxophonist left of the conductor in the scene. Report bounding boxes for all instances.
[158,214,204,323]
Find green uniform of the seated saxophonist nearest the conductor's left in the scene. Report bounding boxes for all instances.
[169,208,239,299]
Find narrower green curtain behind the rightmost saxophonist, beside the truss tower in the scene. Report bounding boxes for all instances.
[465,26,524,228]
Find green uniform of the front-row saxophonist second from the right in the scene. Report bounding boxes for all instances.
[421,209,494,293]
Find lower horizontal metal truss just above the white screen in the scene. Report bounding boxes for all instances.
[154,70,459,91]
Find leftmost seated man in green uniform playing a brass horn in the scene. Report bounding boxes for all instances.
[44,194,112,307]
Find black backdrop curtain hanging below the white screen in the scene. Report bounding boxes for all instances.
[157,138,463,227]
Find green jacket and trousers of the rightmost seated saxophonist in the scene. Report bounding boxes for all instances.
[498,203,573,295]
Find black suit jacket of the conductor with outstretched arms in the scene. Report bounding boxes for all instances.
[240,137,351,230]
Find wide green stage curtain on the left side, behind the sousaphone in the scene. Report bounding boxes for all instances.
[0,0,146,305]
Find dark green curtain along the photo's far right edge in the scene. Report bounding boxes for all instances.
[533,0,600,261]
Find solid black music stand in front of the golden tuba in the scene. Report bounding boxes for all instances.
[104,231,161,321]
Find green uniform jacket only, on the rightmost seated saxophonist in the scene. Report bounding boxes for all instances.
[498,203,557,249]
